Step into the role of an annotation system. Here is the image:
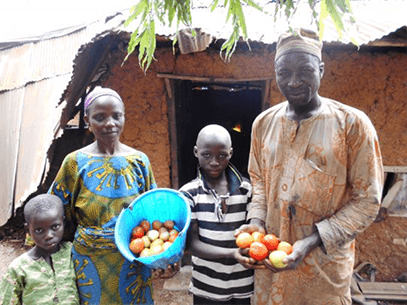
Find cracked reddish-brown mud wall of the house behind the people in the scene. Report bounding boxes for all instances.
[100,46,407,281]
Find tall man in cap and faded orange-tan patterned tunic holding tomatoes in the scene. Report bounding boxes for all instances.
[236,29,383,305]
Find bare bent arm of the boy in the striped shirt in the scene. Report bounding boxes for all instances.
[187,220,238,259]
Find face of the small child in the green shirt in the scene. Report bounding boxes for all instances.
[26,207,64,255]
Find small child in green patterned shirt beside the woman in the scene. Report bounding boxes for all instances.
[0,194,79,304]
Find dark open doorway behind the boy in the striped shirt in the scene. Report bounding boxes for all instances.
[175,81,262,186]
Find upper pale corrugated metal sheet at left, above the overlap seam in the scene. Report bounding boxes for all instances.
[0,16,123,92]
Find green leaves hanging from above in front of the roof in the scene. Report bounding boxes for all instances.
[125,0,356,71]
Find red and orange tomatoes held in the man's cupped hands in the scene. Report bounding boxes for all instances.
[236,232,293,268]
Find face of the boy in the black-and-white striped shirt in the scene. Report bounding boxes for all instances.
[194,137,232,179]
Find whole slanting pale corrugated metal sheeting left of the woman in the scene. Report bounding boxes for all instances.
[0,12,123,226]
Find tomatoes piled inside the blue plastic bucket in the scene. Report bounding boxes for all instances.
[129,219,179,257]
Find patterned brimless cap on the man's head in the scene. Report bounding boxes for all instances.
[274,28,322,61]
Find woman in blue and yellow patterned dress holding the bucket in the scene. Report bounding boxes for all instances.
[50,87,157,304]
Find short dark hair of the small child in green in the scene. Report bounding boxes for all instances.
[24,194,64,223]
